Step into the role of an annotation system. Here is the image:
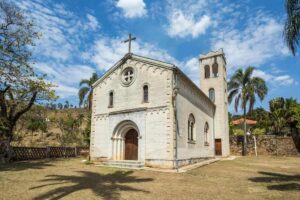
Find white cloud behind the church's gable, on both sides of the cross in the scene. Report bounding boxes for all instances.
[83,37,203,85]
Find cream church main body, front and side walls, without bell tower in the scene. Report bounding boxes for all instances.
[90,51,228,168]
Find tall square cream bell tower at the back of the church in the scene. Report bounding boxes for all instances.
[200,49,230,156]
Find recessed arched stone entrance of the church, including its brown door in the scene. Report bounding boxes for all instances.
[111,120,139,160]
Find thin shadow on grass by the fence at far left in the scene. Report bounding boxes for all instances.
[0,159,55,171]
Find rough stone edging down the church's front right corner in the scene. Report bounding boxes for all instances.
[173,72,179,172]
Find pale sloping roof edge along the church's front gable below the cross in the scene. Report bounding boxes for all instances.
[92,53,176,88]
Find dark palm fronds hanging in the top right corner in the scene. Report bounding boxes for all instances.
[284,0,300,55]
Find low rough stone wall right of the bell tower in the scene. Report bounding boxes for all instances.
[230,135,300,156]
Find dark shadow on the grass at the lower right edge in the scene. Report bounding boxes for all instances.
[249,172,300,191]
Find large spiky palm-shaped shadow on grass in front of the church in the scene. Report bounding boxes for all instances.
[30,171,153,200]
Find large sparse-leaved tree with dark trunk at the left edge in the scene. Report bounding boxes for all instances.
[0,0,56,147]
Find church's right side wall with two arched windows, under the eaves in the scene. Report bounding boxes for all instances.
[177,73,215,160]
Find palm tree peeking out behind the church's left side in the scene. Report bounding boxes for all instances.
[78,73,99,110]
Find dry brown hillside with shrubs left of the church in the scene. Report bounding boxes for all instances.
[12,107,89,147]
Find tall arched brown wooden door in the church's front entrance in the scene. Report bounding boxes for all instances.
[125,129,138,160]
